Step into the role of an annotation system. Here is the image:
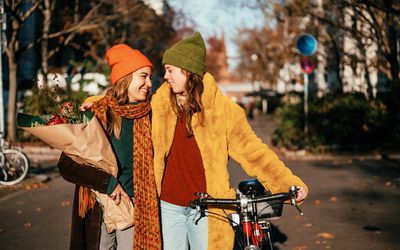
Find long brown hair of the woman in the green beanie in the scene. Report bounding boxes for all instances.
[169,69,205,136]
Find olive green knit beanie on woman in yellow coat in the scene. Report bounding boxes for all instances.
[163,32,206,77]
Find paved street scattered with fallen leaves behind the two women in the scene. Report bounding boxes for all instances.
[0,115,400,250]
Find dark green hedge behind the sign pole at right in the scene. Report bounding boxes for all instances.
[272,94,400,150]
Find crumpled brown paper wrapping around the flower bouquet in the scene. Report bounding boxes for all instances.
[21,117,134,233]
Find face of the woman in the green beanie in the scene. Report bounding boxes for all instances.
[164,64,188,95]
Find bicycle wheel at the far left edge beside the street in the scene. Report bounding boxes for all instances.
[0,148,29,185]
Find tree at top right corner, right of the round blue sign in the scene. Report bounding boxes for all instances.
[285,0,400,98]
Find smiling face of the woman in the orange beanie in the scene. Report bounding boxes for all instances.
[128,66,151,102]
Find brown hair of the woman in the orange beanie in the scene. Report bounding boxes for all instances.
[107,74,133,139]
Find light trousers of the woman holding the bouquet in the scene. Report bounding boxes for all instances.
[99,222,133,250]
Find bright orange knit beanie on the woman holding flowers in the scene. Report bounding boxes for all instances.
[106,44,153,84]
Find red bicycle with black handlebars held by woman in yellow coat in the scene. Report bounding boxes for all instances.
[190,179,303,250]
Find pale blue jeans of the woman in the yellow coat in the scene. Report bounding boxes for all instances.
[161,201,208,250]
